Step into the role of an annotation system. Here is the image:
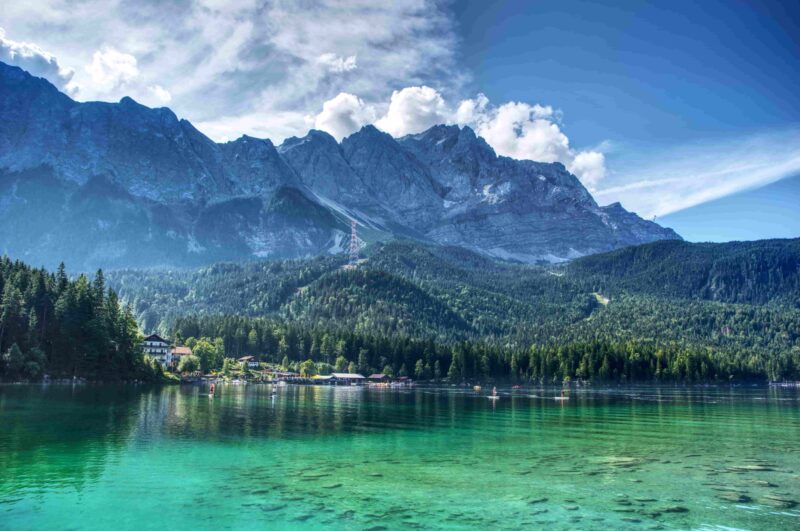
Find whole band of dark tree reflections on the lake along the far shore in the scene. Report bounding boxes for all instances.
[0,385,793,496]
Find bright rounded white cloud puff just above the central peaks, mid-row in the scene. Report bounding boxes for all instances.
[375,86,451,137]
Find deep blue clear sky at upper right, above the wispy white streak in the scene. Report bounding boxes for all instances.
[456,0,800,145]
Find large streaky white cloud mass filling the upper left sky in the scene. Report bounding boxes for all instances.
[0,0,465,142]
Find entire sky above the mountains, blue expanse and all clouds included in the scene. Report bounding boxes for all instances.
[0,0,800,239]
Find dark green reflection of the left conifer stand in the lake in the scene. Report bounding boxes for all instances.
[0,385,141,494]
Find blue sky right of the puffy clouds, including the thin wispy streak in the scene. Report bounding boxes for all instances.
[456,0,800,239]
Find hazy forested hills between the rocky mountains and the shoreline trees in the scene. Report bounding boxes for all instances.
[109,240,800,364]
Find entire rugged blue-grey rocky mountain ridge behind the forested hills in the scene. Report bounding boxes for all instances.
[0,63,680,269]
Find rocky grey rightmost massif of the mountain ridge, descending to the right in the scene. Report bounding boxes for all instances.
[399,126,678,262]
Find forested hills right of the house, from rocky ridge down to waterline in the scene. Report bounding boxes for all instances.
[110,240,800,381]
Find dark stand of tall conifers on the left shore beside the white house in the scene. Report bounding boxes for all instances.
[0,258,156,380]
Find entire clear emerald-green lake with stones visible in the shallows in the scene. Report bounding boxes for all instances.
[0,385,800,530]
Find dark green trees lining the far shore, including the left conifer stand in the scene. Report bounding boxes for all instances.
[0,254,800,383]
